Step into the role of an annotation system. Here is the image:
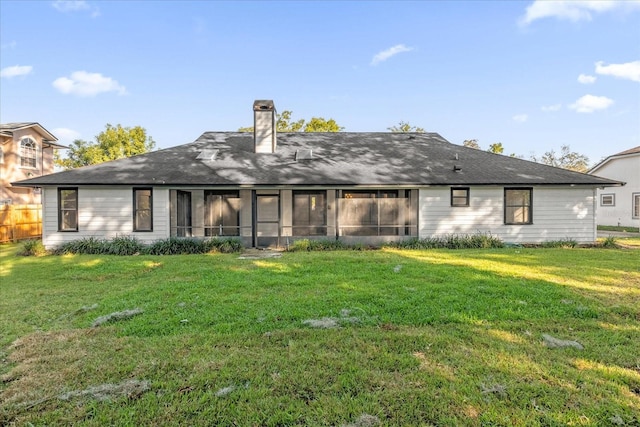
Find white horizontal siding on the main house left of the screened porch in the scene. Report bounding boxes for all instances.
[42,187,169,248]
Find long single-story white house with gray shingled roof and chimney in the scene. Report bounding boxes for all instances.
[15,101,621,247]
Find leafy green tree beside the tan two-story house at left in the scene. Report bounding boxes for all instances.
[54,123,156,169]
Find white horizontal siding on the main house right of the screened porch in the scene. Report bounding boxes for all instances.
[418,187,596,243]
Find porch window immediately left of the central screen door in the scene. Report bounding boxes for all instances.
[204,191,240,236]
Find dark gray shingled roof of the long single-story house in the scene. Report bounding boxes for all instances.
[16,132,620,186]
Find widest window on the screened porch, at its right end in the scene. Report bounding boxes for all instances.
[339,190,400,236]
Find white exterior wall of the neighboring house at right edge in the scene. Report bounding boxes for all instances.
[592,154,640,231]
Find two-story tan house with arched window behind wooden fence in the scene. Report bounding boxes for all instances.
[0,123,66,205]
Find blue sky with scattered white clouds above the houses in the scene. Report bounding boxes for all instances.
[0,0,640,164]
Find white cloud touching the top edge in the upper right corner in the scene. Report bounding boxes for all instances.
[520,0,640,25]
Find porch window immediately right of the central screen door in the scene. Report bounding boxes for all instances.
[293,191,327,236]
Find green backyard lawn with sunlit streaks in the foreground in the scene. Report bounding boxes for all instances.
[0,245,640,426]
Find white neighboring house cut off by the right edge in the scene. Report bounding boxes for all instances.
[589,146,640,228]
